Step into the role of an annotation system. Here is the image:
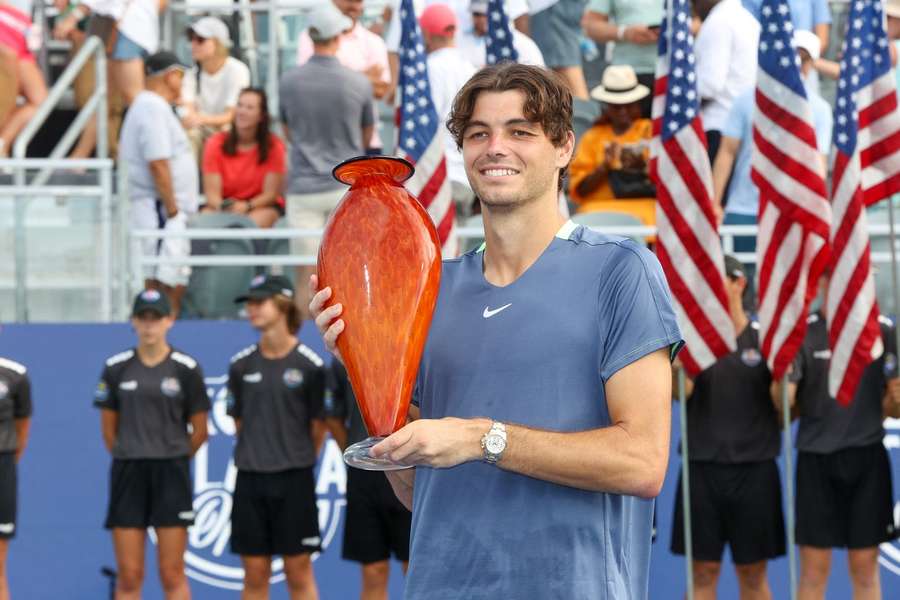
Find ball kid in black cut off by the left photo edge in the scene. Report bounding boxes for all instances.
[0,358,31,598]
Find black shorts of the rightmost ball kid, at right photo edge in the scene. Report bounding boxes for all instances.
[796,442,900,548]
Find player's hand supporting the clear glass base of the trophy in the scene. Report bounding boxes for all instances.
[371,417,491,469]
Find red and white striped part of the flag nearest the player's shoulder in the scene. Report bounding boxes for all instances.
[650,38,736,377]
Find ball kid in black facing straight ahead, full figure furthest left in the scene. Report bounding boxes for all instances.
[94,290,210,599]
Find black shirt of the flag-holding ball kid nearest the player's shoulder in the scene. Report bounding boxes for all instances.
[687,322,781,464]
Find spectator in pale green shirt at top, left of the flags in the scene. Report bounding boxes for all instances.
[582,0,663,118]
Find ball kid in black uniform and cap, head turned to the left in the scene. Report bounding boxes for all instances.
[228,276,325,600]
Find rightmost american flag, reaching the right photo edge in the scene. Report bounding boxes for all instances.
[825,0,900,405]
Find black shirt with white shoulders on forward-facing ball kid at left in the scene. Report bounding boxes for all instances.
[94,349,210,459]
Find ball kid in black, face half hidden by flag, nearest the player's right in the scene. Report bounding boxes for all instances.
[671,256,785,599]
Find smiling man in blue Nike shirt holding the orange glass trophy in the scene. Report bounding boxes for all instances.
[310,64,682,600]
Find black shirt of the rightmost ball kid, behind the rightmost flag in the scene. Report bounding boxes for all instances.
[792,314,897,454]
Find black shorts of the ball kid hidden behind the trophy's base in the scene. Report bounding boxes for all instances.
[341,468,412,564]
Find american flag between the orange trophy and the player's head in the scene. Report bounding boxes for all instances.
[397,0,457,257]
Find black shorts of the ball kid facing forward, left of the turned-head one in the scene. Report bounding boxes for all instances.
[104,456,194,529]
